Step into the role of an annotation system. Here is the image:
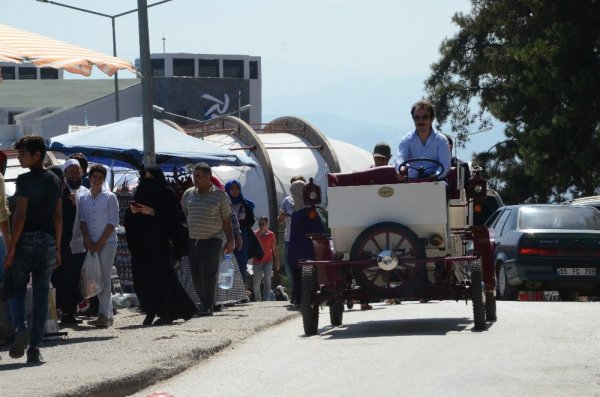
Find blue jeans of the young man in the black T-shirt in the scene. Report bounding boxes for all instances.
[10,232,56,347]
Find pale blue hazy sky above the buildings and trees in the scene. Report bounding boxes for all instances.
[0,0,502,157]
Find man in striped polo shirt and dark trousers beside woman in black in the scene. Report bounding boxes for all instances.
[181,163,235,316]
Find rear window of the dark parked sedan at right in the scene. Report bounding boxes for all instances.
[519,206,600,230]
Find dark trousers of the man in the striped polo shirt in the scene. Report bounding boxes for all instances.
[190,238,222,311]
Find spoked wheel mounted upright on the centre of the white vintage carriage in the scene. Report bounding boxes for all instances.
[350,222,426,298]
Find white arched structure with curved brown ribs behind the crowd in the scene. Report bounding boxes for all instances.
[184,116,372,238]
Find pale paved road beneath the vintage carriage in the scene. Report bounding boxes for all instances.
[135,302,600,397]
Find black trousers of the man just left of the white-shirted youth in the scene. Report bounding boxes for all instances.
[51,248,86,314]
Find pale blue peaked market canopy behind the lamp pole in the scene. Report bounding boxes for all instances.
[48,117,256,169]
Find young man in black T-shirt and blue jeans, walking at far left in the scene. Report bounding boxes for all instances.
[5,135,62,363]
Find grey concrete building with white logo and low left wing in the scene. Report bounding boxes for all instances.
[0,54,262,148]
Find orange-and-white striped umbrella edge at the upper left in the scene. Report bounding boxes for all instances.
[0,24,137,76]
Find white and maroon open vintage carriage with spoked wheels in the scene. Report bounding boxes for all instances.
[300,159,496,335]
